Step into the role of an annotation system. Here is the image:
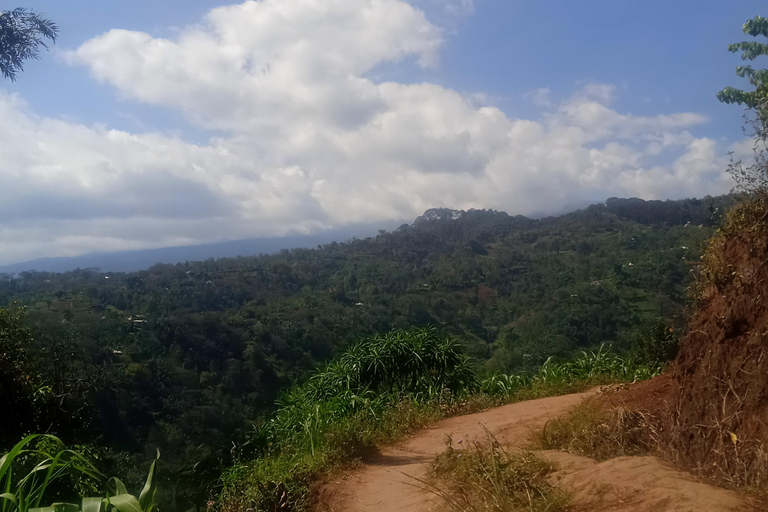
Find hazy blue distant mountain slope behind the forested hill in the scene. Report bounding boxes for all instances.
[0,223,398,274]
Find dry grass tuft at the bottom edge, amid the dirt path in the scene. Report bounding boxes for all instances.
[430,432,570,512]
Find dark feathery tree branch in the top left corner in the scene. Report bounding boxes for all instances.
[0,7,59,81]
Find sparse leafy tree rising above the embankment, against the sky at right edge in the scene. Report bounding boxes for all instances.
[717,16,768,194]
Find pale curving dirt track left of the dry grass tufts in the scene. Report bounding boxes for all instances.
[323,391,594,512]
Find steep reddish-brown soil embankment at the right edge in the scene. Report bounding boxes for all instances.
[662,200,768,487]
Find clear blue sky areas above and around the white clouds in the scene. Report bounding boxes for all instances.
[10,0,765,138]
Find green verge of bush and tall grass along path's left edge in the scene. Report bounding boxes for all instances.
[218,329,661,512]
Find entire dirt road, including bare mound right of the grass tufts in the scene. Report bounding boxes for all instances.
[322,391,754,512]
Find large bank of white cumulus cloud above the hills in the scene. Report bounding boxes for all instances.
[0,0,729,261]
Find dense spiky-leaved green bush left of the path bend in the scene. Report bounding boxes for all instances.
[257,328,475,454]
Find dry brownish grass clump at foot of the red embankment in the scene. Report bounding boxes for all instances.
[538,402,658,461]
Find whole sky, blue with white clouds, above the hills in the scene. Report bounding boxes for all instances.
[0,0,766,264]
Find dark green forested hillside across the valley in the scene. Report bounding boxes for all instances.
[0,196,733,510]
